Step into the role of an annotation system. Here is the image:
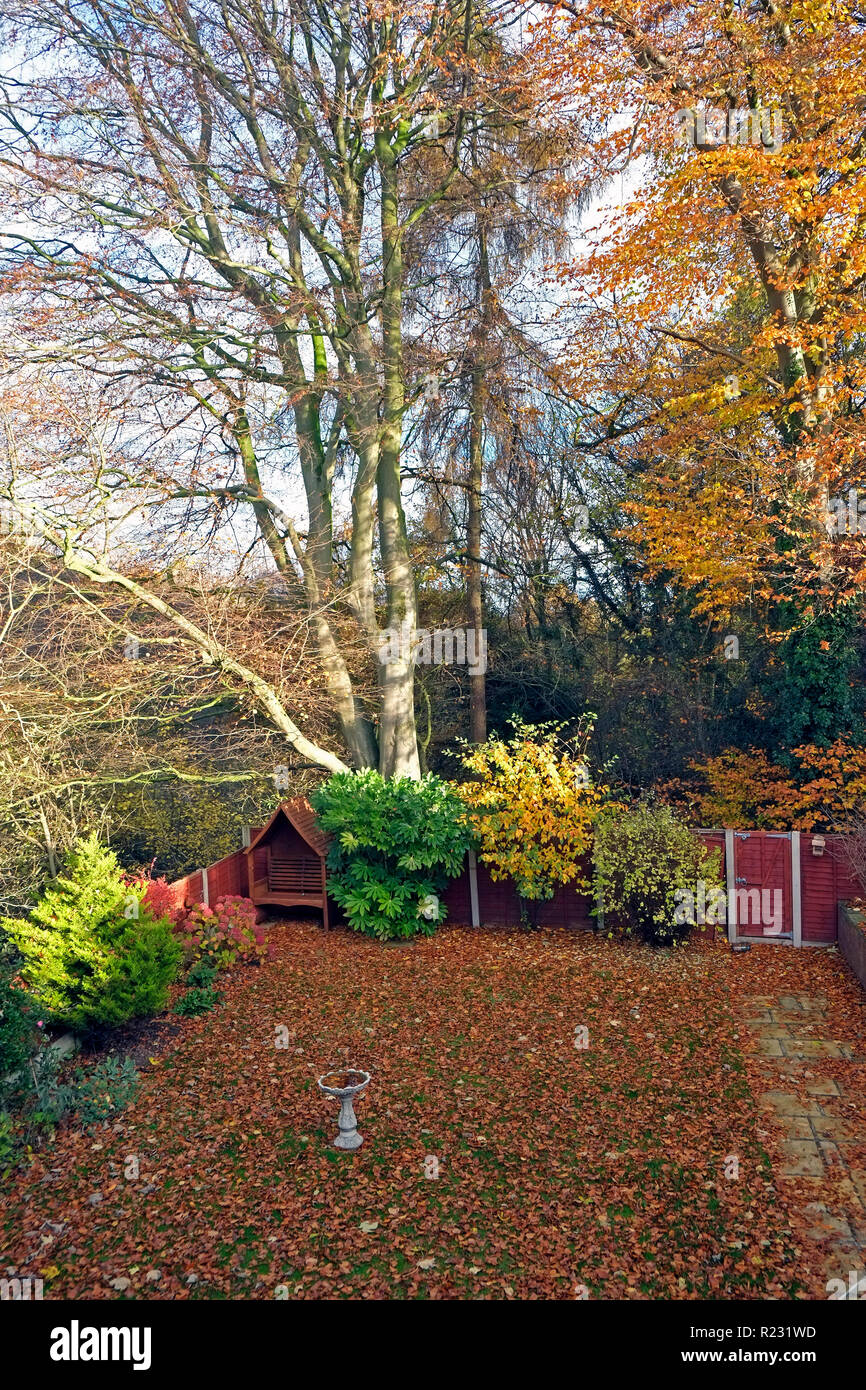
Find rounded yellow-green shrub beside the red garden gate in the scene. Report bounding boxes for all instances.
[592,802,720,945]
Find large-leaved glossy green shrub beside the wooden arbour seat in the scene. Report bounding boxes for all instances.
[313,770,471,938]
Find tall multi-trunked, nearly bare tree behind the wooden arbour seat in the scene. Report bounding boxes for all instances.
[0,0,542,776]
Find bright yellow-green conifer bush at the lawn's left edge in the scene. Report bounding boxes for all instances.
[0,835,182,1030]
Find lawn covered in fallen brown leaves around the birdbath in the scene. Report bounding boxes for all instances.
[0,923,847,1298]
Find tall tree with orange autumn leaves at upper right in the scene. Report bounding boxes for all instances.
[537,0,866,621]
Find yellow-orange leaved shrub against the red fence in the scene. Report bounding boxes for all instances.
[460,719,606,922]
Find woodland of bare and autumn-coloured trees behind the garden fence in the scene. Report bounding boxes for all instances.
[0,0,866,910]
